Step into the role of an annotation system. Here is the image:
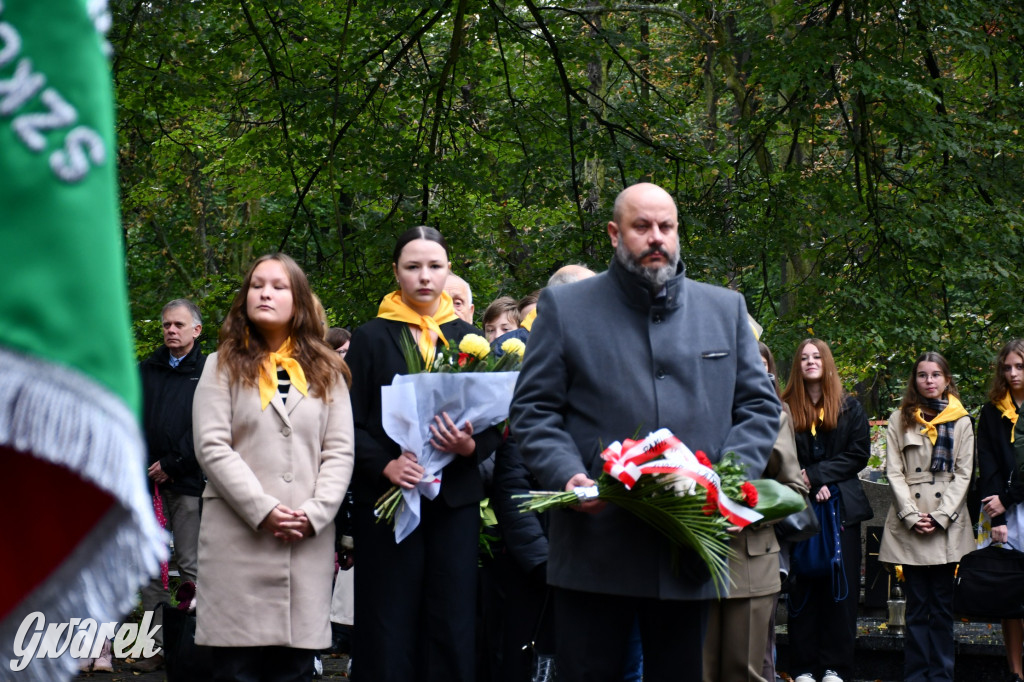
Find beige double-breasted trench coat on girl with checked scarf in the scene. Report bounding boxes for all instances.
[879,410,975,566]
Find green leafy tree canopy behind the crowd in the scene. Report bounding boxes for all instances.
[112,0,1024,417]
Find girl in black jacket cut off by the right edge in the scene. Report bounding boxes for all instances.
[976,339,1024,682]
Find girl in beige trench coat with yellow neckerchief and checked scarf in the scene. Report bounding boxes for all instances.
[879,352,974,681]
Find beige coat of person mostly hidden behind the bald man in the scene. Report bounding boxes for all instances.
[729,410,807,599]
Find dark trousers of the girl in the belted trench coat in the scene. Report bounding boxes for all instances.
[903,561,956,682]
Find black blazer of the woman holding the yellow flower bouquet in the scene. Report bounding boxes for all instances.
[345,317,501,507]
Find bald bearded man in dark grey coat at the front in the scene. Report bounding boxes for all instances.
[511,183,780,682]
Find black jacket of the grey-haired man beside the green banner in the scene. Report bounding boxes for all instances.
[138,343,206,496]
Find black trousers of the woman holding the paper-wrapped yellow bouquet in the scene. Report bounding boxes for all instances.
[352,498,480,682]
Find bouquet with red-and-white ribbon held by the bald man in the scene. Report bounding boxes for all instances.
[517,429,805,593]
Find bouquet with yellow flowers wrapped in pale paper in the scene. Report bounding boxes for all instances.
[376,334,525,543]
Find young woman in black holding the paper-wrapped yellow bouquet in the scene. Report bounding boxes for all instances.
[345,227,501,682]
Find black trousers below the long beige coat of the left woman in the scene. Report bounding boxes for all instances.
[210,646,316,682]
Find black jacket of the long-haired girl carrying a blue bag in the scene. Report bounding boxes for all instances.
[797,395,874,525]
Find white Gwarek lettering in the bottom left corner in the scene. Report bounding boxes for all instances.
[10,611,161,673]
